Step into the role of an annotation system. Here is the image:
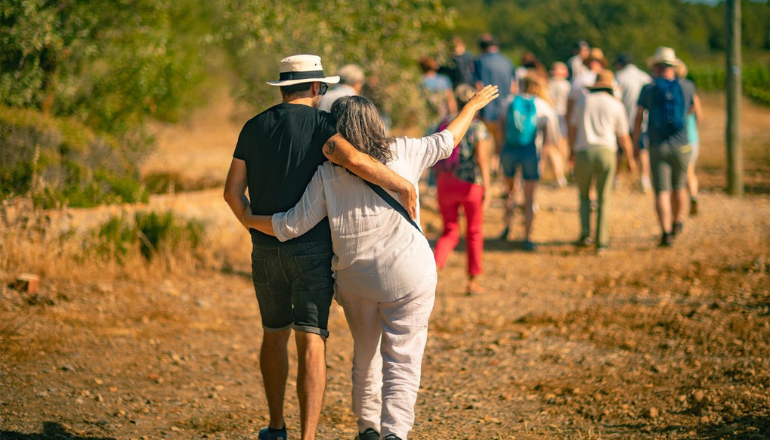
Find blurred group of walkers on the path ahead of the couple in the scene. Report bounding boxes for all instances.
[423,35,701,279]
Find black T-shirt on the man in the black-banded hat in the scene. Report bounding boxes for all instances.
[233,103,337,248]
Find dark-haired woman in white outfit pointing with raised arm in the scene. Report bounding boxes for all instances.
[243,86,498,440]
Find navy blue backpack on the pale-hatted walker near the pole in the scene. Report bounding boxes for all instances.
[649,78,686,139]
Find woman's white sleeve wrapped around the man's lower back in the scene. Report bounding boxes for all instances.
[272,165,328,241]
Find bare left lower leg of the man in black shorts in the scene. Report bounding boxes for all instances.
[259,329,291,429]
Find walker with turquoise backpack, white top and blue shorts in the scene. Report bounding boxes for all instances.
[498,75,560,252]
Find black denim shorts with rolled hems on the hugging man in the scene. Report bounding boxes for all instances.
[251,242,334,337]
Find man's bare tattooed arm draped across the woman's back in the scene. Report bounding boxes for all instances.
[324,134,417,219]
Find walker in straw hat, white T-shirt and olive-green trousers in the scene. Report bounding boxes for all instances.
[570,70,636,253]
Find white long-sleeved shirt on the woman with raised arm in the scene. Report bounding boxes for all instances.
[272,130,455,302]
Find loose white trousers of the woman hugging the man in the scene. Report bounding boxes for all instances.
[337,272,437,440]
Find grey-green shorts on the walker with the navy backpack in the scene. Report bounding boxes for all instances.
[650,143,692,194]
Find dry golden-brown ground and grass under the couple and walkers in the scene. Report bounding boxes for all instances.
[0,91,770,440]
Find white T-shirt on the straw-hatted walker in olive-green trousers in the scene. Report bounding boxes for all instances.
[570,92,628,151]
